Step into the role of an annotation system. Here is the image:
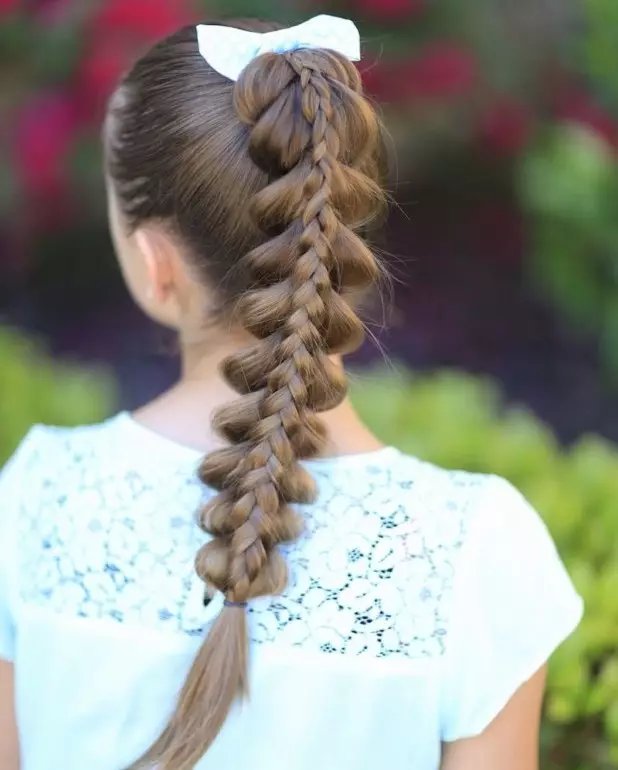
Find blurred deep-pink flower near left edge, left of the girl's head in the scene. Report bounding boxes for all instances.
[14,93,76,199]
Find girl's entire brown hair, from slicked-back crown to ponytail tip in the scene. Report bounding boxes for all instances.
[106,22,383,770]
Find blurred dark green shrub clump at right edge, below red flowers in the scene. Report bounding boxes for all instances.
[521,126,618,383]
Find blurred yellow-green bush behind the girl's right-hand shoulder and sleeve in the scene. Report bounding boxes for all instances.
[353,371,618,770]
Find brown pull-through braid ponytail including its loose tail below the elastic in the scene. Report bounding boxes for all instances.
[132,49,382,770]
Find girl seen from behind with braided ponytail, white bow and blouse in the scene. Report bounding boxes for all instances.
[0,17,581,770]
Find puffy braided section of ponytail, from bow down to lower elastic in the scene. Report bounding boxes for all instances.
[197,52,377,602]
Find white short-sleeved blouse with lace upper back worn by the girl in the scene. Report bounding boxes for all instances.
[0,413,582,770]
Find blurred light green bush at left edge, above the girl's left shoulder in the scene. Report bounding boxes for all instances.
[0,327,114,466]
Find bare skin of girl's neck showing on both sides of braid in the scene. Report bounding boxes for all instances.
[133,334,382,456]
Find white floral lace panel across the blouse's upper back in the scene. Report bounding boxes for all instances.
[19,418,485,658]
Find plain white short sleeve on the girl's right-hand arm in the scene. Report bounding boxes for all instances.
[441,476,583,742]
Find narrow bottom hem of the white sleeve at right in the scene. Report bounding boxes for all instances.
[442,596,584,743]
